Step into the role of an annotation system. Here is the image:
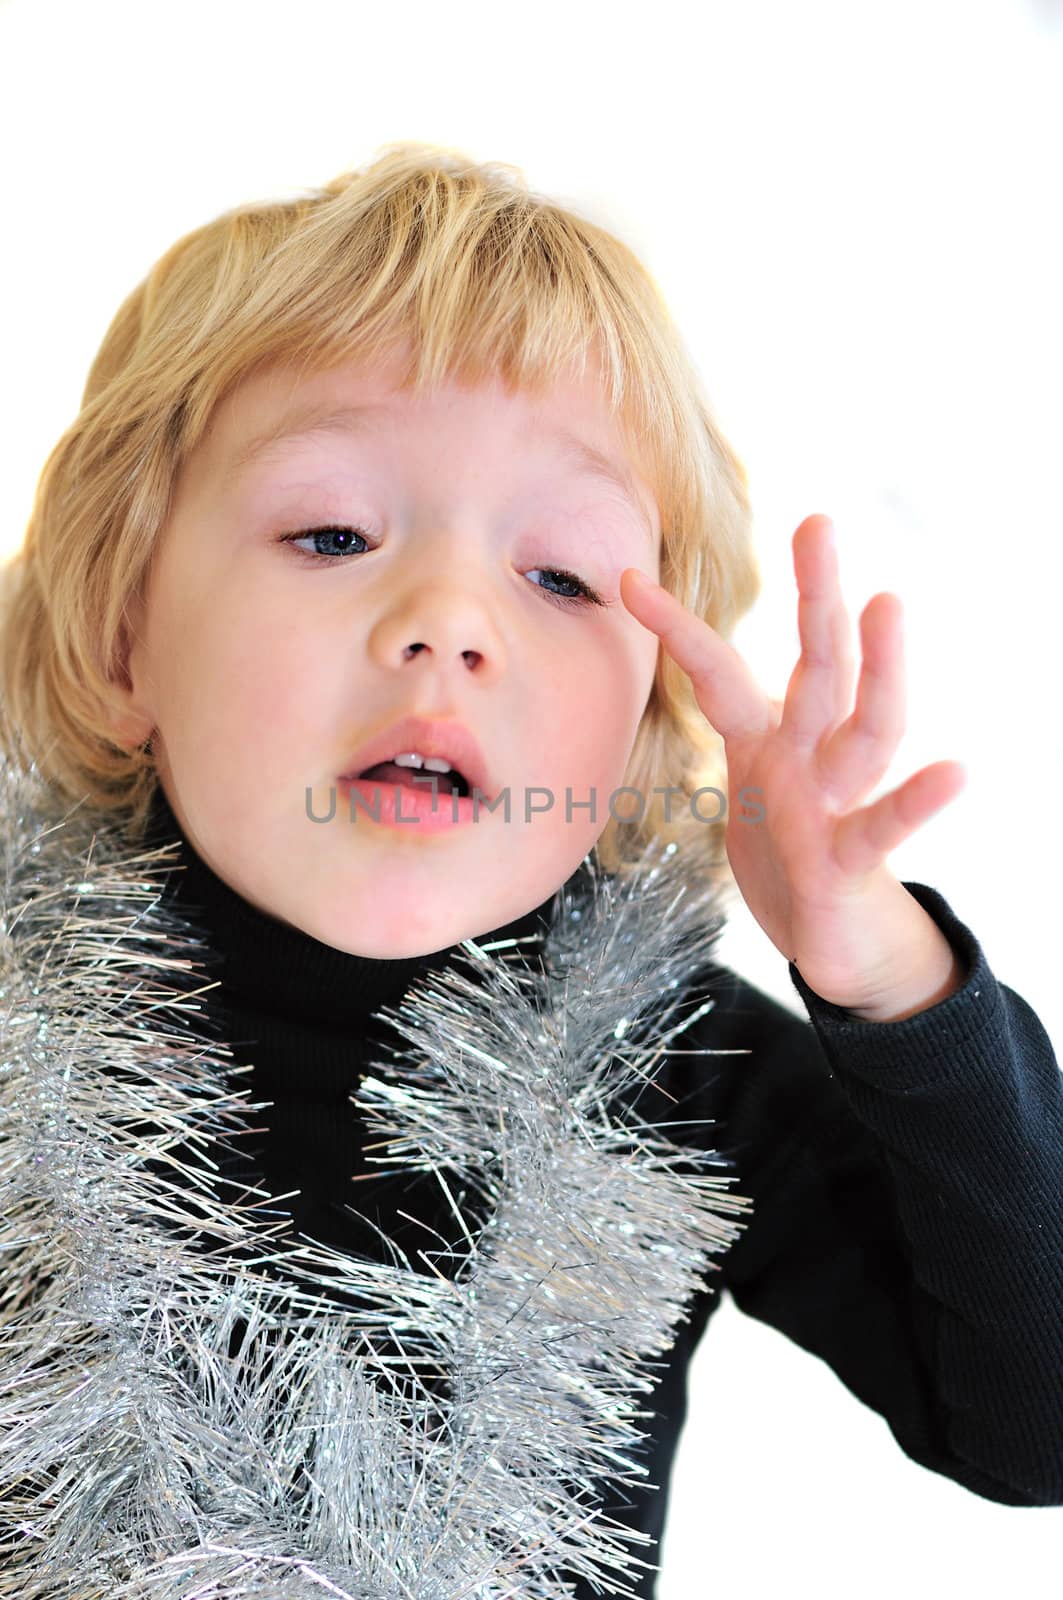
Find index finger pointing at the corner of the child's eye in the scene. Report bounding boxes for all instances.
[620,566,778,739]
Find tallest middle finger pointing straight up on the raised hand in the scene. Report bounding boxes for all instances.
[783,515,855,746]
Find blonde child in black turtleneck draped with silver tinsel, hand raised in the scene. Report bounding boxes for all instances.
[0,146,1063,1600]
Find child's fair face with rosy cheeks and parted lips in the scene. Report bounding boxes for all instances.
[120,345,660,958]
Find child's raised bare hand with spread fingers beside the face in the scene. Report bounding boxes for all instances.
[620,515,967,1021]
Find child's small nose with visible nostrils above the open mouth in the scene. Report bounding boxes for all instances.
[368,578,506,682]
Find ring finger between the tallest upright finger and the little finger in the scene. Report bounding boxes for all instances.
[815,594,906,806]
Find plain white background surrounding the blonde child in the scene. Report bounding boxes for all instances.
[0,0,1063,1600]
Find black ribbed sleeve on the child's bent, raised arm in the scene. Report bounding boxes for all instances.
[706,883,1063,1506]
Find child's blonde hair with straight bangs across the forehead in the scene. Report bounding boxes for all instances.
[0,142,760,886]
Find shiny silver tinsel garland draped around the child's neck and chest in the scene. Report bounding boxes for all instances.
[0,763,752,1600]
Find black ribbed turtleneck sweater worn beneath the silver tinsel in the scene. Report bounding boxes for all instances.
[143,789,1063,1600]
